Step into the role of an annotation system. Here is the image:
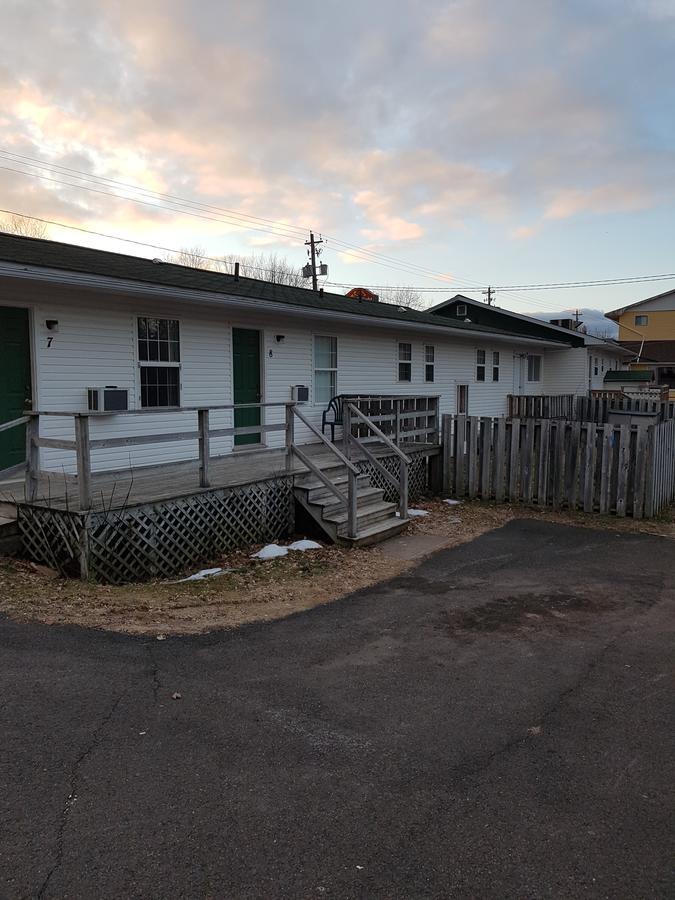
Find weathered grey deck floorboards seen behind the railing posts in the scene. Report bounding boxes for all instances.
[0,442,438,517]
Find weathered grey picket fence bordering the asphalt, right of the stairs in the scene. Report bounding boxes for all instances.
[442,415,675,518]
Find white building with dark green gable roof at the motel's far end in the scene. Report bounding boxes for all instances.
[430,294,631,396]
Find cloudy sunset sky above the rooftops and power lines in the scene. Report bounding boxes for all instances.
[0,0,675,313]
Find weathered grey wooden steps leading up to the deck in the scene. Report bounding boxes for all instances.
[293,463,409,547]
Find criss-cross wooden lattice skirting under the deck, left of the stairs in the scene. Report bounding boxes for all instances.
[18,478,294,584]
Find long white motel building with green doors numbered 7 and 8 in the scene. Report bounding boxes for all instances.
[0,234,586,472]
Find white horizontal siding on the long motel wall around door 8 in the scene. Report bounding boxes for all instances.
[9,287,585,472]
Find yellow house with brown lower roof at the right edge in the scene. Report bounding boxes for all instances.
[606,290,675,399]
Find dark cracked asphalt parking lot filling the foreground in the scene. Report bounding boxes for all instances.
[0,520,675,900]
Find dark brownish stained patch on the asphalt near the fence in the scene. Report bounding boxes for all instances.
[445,592,615,635]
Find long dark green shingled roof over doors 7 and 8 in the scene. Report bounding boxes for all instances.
[0,232,572,344]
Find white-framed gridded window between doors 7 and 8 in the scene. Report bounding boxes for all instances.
[138,316,180,409]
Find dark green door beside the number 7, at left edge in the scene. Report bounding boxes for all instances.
[0,306,32,472]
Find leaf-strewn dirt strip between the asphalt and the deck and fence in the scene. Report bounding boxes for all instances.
[0,500,675,635]
